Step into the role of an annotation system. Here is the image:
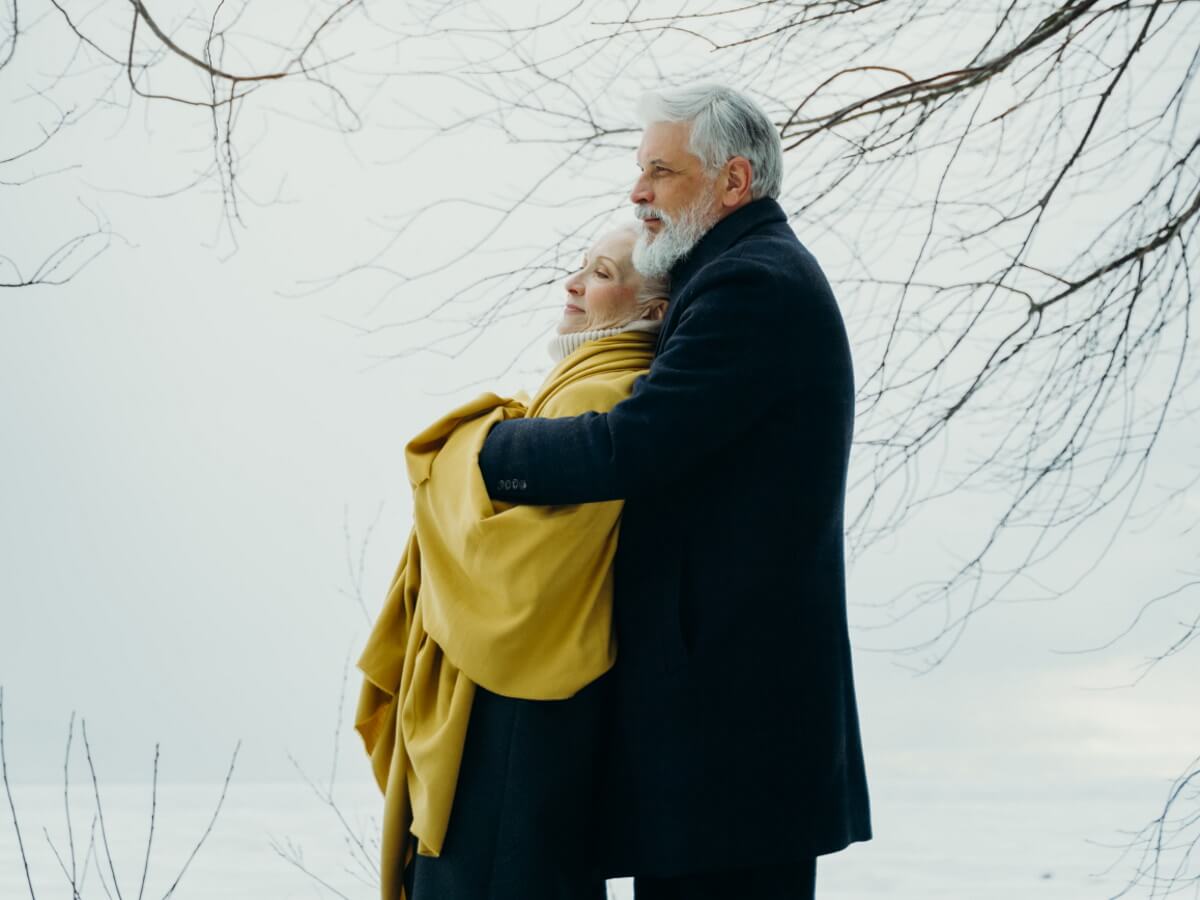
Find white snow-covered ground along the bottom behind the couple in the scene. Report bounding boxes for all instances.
[0,773,1166,900]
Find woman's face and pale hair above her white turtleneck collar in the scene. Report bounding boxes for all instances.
[558,229,666,335]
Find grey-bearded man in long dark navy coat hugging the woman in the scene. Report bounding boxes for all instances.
[479,85,871,900]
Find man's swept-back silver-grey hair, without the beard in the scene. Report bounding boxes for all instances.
[637,84,784,200]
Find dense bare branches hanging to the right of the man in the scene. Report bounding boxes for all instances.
[758,1,1200,665]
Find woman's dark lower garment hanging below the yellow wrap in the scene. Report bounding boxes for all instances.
[404,678,606,900]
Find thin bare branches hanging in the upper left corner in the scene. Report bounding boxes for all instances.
[0,0,360,288]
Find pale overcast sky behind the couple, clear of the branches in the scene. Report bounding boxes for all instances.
[0,5,1200,897]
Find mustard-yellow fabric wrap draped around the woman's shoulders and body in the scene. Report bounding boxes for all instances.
[354,331,655,900]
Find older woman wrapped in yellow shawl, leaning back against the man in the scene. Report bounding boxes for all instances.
[355,226,667,900]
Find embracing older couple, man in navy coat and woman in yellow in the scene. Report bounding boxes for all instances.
[355,85,871,900]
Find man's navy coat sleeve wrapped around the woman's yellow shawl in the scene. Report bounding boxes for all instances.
[479,259,804,504]
